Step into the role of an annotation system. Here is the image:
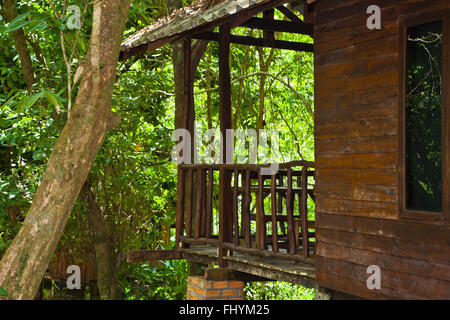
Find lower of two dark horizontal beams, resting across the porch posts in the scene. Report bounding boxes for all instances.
[193,32,314,52]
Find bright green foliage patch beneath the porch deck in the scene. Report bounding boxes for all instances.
[244,281,316,300]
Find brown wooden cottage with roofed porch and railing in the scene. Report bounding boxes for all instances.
[121,0,450,299]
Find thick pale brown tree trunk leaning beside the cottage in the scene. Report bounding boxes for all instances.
[0,0,130,299]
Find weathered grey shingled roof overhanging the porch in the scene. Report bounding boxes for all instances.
[122,0,294,51]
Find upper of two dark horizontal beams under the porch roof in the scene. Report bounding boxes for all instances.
[241,17,314,36]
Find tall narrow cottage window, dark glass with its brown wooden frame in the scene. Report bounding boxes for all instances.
[399,13,448,219]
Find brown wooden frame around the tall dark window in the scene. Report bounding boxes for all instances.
[398,9,450,224]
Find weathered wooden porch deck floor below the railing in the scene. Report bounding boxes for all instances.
[182,246,317,289]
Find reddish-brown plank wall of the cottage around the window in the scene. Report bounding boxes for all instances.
[314,0,450,299]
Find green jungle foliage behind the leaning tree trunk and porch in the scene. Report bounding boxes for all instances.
[0,0,314,299]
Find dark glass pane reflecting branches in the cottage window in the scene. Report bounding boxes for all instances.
[405,21,443,212]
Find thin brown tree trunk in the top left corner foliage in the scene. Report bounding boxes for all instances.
[4,0,34,91]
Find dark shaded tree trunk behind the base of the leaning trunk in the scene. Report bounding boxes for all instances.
[83,184,120,300]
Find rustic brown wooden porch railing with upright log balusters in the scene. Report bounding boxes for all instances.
[176,161,315,266]
